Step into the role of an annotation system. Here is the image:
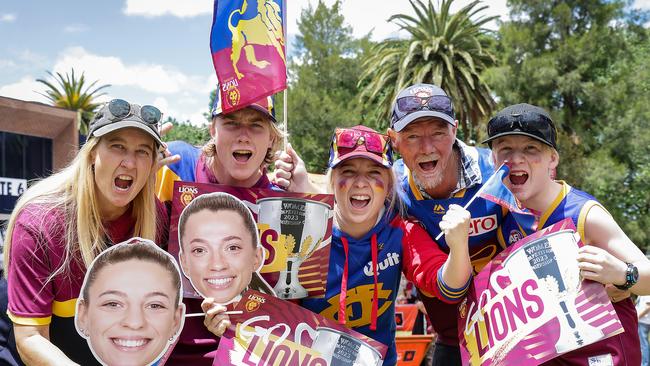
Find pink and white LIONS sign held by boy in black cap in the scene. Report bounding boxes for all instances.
[458,219,623,365]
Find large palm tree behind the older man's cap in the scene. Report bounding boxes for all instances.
[359,0,496,138]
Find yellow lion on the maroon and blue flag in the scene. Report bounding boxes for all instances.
[228,0,286,79]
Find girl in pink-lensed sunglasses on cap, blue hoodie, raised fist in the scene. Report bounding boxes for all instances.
[302,126,472,365]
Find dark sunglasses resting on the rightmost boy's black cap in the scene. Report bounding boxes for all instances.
[485,112,557,148]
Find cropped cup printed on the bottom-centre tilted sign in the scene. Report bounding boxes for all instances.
[311,327,383,366]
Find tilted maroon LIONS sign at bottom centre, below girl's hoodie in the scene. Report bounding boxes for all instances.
[213,290,387,366]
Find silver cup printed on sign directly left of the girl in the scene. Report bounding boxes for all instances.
[257,197,332,299]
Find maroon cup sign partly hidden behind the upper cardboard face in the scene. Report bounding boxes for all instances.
[168,181,334,303]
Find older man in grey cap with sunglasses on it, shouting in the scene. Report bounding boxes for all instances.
[276,84,526,365]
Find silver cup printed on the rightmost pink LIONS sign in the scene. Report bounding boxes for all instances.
[504,230,603,354]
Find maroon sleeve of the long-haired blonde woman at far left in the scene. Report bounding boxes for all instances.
[7,206,54,325]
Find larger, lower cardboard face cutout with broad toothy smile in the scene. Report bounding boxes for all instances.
[75,238,185,366]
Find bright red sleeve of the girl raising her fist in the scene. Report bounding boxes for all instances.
[402,220,447,299]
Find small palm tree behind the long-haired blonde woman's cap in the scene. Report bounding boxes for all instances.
[36,68,110,135]
